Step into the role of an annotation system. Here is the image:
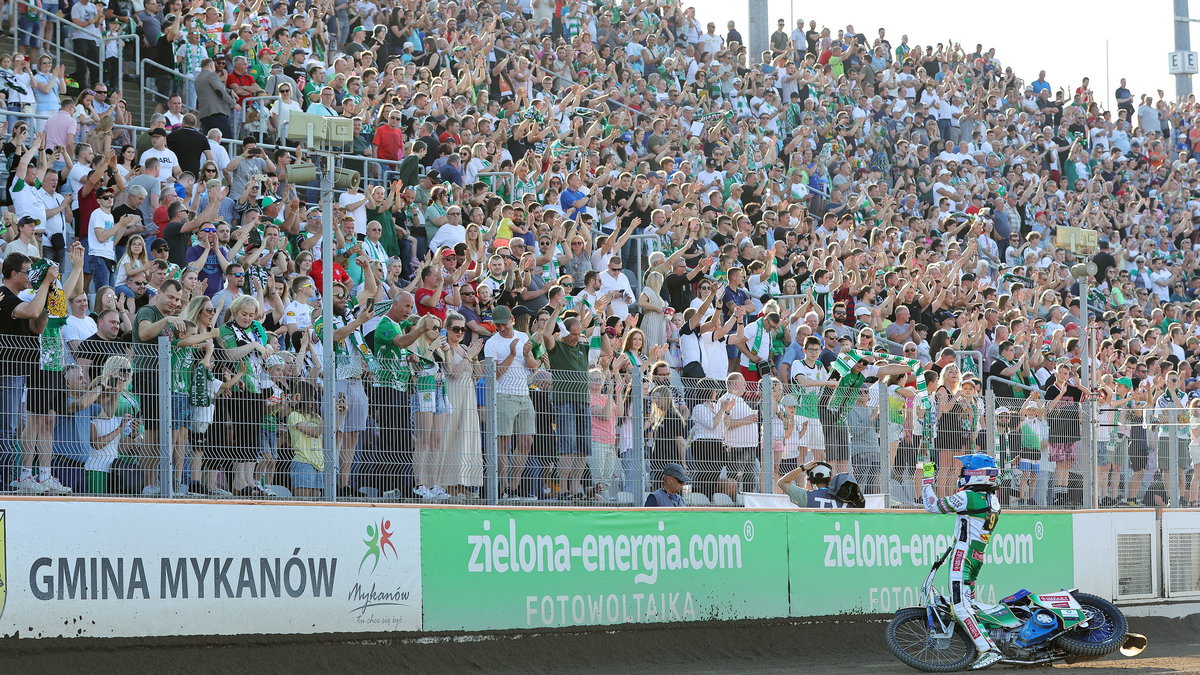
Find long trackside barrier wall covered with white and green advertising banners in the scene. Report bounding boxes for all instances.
[0,497,1185,638]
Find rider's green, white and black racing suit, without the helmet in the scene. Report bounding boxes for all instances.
[922,483,1000,653]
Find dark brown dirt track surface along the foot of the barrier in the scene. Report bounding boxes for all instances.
[0,615,1200,675]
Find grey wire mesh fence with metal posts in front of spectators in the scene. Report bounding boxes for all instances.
[0,324,1200,508]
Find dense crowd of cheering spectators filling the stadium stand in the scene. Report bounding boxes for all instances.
[0,0,1200,504]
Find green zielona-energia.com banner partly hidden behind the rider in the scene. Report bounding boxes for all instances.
[788,509,1086,616]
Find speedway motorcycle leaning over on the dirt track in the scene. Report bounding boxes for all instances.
[887,548,1147,673]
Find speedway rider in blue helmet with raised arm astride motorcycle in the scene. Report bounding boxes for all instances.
[922,454,1003,670]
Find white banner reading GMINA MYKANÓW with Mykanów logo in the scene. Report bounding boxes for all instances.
[0,498,421,638]
